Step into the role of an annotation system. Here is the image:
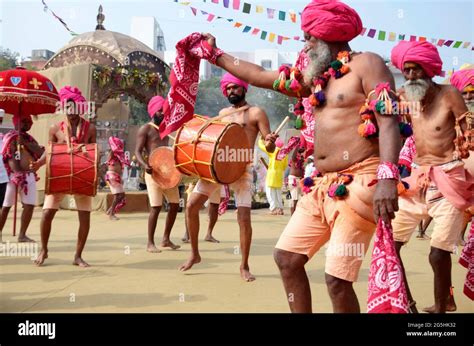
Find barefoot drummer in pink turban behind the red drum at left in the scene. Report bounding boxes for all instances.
[35,86,96,268]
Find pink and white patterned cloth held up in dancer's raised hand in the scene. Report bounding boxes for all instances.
[160,32,224,139]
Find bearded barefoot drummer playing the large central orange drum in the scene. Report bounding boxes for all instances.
[179,73,277,282]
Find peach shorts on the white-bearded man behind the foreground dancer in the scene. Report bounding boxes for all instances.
[392,162,465,252]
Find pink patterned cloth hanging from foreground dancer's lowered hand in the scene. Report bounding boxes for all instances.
[367,219,408,313]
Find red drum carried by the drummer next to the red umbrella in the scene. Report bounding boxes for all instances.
[46,143,99,196]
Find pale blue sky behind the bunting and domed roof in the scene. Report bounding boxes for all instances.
[0,0,474,78]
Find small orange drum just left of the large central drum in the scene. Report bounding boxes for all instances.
[148,147,181,190]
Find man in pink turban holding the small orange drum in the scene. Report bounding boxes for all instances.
[135,96,180,253]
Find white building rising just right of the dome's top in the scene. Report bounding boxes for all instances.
[130,16,166,52]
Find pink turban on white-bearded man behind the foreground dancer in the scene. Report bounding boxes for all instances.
[391,41,443,78]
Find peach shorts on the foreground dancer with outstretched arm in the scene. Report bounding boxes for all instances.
[275,158,379,282]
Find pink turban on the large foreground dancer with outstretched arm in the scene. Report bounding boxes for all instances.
[301,0,362,42]
